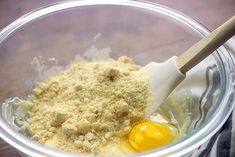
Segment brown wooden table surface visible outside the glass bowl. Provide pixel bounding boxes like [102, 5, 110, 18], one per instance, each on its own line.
[0, 0, 235, 157]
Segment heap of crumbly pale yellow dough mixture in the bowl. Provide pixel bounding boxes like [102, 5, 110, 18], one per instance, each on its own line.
[28, 56, 150, 154]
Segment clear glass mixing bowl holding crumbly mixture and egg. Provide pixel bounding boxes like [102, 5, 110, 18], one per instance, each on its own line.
[0, 0, 234, 157]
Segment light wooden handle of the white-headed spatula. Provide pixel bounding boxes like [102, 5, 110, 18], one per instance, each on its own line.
[176, 15, 235, 73]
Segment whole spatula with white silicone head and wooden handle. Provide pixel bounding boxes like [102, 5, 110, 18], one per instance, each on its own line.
[145, 16, 235, 115]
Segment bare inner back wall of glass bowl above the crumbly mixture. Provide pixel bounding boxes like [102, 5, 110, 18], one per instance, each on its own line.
[0, 6, 204, 99]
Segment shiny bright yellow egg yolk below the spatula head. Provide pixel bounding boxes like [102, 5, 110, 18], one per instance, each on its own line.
[128, 121, 174, 152]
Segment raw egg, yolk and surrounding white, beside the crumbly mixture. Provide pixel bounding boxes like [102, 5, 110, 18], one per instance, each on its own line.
[98, 114, 179, 157]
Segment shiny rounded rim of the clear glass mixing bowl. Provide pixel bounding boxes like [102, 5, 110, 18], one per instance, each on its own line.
[0, 0, 234, 157]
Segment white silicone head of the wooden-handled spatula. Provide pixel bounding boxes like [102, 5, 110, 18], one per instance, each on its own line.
[145, 56, 185, 116]
